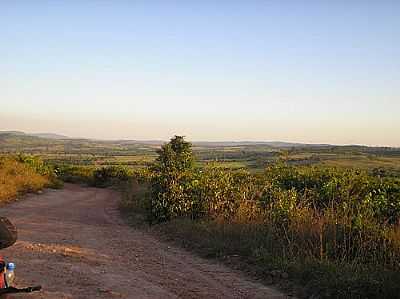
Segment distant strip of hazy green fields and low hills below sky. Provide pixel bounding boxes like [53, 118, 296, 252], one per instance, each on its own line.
[0, 131, 400, 176]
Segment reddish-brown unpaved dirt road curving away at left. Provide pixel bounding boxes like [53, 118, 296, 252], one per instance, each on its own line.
[0, 184, 286, 299]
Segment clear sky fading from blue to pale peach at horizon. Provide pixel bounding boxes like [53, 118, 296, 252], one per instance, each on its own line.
[0, 0, 400, 146]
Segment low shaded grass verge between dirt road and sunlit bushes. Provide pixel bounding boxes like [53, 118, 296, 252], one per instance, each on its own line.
[121, 181, 400, 298]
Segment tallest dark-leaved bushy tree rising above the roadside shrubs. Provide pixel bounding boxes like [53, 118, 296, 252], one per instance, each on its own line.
[149, 136, 194, 222]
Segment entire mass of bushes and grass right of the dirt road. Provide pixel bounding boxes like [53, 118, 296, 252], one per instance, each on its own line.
[124, 136, 400, 298]
